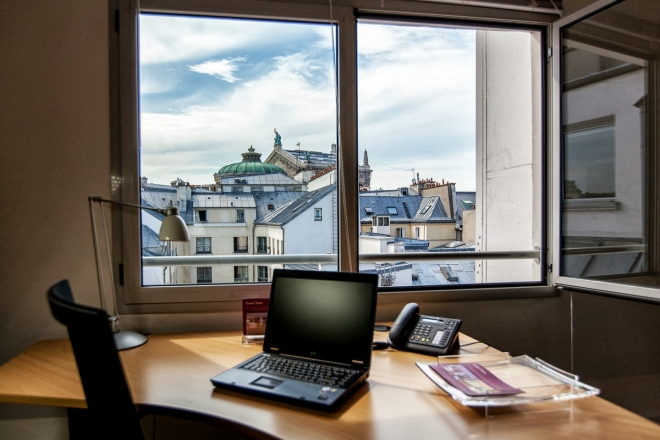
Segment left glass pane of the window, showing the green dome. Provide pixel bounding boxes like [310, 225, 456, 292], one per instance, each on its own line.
[139, 13, 338, 286]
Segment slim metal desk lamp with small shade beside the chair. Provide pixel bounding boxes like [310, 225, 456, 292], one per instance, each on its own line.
[89, 197, 190, 350]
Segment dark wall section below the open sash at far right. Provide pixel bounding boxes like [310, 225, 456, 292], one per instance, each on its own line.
[564, 291, 660, 422]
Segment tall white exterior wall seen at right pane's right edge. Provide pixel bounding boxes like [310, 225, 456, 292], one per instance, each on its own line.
[475, 31, 542, 283]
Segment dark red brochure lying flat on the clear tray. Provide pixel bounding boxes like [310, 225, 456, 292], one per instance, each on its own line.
[430, 363, 524, 396]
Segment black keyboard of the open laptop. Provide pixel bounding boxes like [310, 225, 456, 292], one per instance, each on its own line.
[241, 356, 358, 388]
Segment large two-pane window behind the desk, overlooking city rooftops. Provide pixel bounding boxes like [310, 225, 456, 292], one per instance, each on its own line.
[117, 0, 552, 311]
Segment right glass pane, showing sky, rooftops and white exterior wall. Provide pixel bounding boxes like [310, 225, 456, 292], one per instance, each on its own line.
[358, 20, 544, 288]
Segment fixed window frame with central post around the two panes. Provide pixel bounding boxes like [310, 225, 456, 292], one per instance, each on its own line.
[109, 0, 554, 313]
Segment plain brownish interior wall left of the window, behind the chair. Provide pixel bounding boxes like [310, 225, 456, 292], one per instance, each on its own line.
[0, 0, 110, 438]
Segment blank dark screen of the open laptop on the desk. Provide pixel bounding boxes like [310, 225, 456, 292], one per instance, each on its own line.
[264, 270, 378, 367]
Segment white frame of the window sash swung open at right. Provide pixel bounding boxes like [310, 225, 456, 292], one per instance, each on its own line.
[550, 0, 660, 300]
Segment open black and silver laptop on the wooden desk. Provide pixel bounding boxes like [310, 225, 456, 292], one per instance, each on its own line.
[211, 269, 378, 411]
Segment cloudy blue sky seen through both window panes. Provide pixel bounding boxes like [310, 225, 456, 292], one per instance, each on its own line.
[140, 14, 475, 191]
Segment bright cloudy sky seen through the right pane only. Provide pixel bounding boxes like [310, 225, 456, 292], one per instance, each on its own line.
[358, 24, 476, 190]
